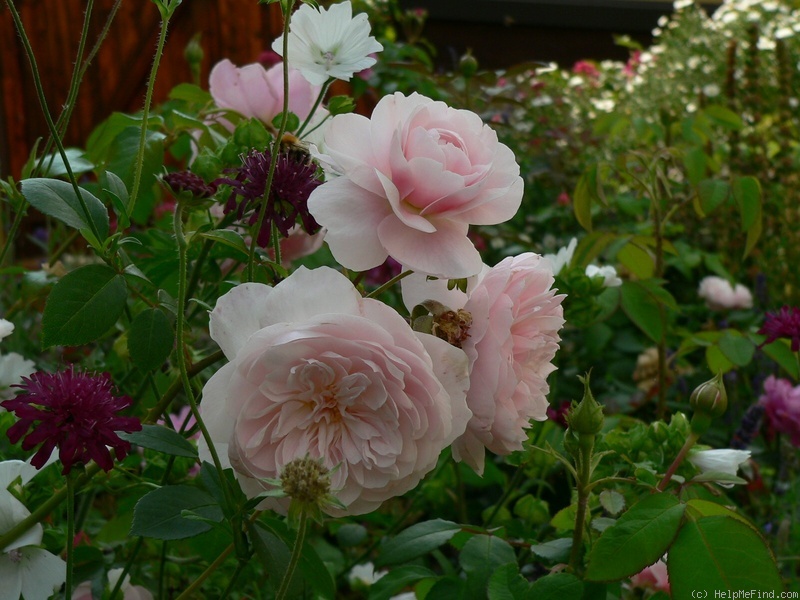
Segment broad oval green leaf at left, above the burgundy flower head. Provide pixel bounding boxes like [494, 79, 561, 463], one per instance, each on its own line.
[42, 265, 128, 348]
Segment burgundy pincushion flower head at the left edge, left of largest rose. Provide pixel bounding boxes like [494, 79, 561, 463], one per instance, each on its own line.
[0, 367, 142, 474]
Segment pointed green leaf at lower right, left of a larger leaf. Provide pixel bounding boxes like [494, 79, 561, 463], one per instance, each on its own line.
[586, 493, 686, 581]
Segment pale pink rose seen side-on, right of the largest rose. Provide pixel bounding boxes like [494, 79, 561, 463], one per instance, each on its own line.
[403, 253, 564, 473]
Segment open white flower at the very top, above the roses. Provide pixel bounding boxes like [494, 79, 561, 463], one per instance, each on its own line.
[272, 0, 383, 85]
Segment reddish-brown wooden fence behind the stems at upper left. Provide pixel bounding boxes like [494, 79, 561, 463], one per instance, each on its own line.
[0, 0, 282, 178]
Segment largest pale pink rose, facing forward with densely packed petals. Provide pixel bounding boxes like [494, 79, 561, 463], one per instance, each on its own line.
[201, 267, 471, 516]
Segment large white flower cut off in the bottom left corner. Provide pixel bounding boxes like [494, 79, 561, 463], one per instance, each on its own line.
[0, 460, 67, 600]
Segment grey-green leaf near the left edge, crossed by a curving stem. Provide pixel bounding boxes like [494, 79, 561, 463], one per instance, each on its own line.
[20, 178, 108, 241]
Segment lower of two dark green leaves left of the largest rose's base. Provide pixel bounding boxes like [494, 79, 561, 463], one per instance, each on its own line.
[131, 485, 222, 540]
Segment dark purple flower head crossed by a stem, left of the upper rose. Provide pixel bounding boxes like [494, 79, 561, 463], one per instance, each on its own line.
[219, 150, 322, 248]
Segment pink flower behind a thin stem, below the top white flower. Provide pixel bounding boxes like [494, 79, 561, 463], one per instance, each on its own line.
[208, 58, 320, 124]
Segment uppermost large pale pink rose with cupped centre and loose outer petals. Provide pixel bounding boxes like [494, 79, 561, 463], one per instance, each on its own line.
[308, 92, 523, 278]
